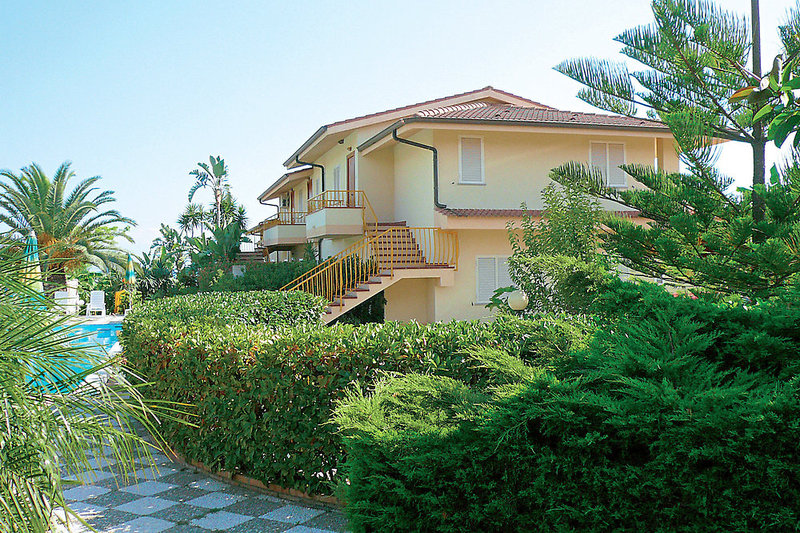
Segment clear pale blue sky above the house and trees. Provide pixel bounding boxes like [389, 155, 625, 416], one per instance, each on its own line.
[0, 0, 793, 251]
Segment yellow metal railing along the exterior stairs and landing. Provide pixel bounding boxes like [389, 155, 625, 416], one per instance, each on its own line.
[281, 226, 459, 307]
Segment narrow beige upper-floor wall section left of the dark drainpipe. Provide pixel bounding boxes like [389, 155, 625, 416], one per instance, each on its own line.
[392, 130, 434, 227]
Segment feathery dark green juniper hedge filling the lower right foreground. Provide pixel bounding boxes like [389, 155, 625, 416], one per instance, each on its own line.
[336, 284, 800, 532]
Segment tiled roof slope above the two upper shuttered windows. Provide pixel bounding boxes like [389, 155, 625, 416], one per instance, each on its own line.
[416, 102, 669, 130]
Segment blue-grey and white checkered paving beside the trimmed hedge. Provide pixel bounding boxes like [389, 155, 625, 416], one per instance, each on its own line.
[57, 448, 346, 533]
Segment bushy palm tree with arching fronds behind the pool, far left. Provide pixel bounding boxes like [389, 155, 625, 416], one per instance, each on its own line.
[0, 162, 136, 284]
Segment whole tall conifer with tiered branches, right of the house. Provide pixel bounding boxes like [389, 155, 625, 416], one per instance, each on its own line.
[551, 0, 800, 298]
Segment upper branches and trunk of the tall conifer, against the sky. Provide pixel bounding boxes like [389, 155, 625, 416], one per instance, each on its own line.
[556, 0, 780, 221]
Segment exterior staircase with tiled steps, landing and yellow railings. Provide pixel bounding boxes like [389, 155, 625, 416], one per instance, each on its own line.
[282, 222, 458, 324]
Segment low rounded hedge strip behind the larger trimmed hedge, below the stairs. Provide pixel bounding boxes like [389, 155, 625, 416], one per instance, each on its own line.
[122, 291, 325, 332]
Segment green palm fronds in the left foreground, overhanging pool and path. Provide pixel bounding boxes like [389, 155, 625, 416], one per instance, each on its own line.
[0, 243, 174, 533]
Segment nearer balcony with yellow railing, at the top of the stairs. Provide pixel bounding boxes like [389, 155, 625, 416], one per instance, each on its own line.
[306, 190, 377, 239]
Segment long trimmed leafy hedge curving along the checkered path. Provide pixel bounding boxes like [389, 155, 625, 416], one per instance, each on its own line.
[122, 318, 588, 493]
